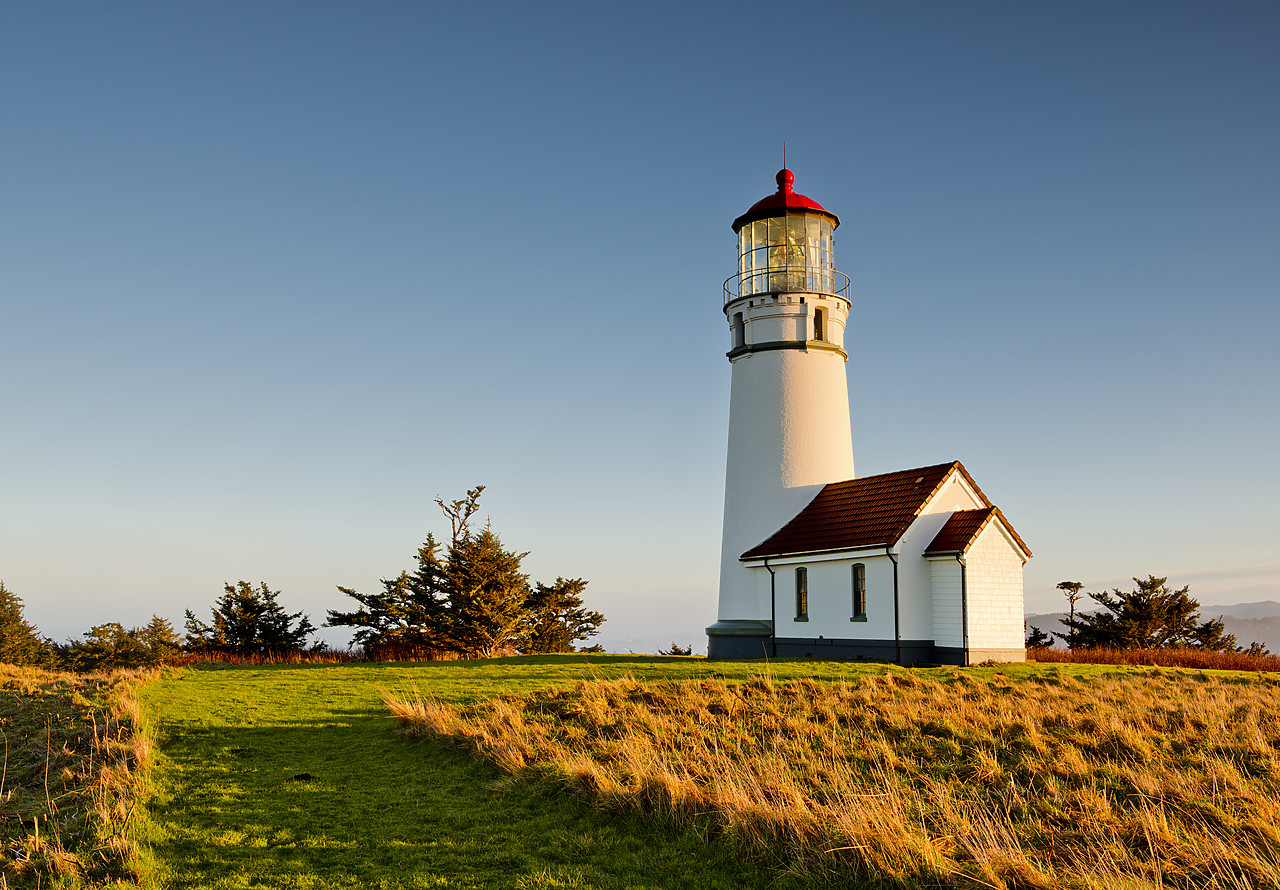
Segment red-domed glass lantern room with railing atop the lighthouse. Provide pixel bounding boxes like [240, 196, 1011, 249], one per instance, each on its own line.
[724, 169, 849, 306]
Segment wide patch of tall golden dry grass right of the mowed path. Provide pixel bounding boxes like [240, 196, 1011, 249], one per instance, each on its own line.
[387, 667, 1280, 890]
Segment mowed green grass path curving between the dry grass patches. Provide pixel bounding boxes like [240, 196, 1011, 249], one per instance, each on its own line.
[142, 656, 942, 889]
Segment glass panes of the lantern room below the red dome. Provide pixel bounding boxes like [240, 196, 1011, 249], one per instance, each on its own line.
[737, 214, 836, 297]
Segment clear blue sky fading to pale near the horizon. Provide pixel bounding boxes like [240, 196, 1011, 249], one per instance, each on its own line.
[0, 1, 1280, 651]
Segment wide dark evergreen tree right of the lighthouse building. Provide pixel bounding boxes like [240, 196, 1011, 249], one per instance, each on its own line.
[1057, 575, 1235, 651]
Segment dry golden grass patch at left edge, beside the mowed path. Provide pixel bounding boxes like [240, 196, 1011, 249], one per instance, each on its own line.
[0, 663, 155, 887]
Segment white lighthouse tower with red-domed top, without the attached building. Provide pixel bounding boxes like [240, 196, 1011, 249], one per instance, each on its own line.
[707, 169, 854, 658]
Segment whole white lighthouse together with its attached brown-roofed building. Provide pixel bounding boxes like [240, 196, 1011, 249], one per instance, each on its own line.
[707, 170, 1032, 665]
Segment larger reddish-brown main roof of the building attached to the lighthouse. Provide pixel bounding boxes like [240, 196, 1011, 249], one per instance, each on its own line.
[739, 461, 1030, 560]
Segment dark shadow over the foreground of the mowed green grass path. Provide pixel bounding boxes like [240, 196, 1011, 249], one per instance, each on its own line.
[151, 701, 801, 889]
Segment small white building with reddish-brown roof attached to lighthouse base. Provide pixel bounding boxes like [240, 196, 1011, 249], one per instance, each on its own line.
[708, 461, 1032, 665]
